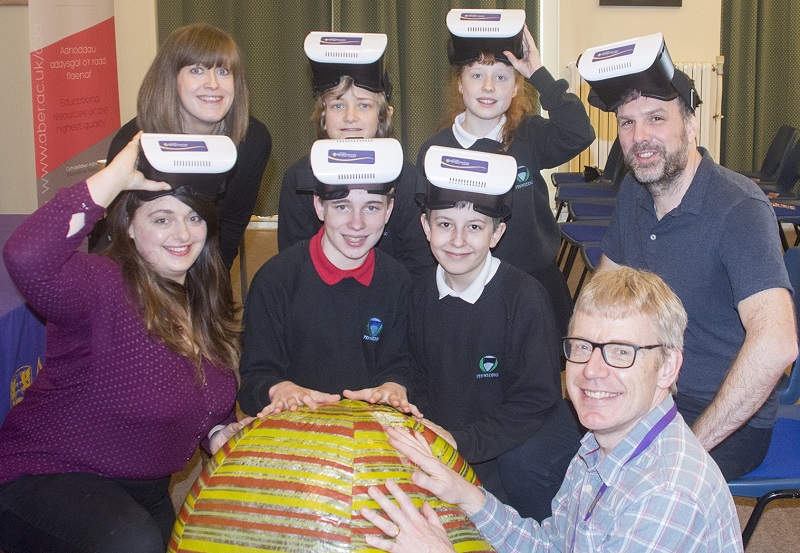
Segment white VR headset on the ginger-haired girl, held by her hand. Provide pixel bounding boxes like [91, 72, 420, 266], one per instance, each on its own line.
[447, 9, 525, 65]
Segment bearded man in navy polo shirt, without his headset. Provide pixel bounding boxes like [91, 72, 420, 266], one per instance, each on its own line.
[590, 69, 798, 480]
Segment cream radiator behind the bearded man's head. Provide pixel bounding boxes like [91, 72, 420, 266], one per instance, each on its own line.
[564, 56, 725, 171]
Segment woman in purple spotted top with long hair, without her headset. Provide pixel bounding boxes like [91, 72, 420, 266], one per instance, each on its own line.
[0, 136, 246, 553]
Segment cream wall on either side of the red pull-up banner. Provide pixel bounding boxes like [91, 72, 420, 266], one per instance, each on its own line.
[0, 0, 156, 213]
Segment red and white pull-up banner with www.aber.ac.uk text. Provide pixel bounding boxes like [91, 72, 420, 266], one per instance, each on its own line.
[28, 0, 120, 205]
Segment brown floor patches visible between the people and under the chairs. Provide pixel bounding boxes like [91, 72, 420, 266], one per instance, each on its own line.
[166, 219, 800, 553]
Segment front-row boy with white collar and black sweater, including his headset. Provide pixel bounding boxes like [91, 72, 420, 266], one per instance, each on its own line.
[410, 146, 581, 520]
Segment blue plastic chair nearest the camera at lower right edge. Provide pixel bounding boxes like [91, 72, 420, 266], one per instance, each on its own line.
[728, 247, 800, 547]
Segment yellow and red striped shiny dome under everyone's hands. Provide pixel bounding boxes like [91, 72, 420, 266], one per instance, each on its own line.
[168, 400, 494, 553]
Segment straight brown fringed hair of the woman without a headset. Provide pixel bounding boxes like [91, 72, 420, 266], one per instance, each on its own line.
[136, 23, 249, 146]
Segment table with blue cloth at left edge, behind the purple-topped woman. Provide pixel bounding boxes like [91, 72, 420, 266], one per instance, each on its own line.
[0, 215, 44, 422]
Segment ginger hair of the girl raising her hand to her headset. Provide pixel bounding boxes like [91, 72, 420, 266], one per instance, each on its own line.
[440, 52, 536, 152]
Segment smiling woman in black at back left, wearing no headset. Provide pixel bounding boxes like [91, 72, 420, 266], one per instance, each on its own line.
[90, 23, 272, 269]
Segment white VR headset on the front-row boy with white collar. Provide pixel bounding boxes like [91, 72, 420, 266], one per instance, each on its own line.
[416, 146, 517, 218]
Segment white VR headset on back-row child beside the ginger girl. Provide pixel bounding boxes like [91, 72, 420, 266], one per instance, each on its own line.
[303, 31, 392, 98]
